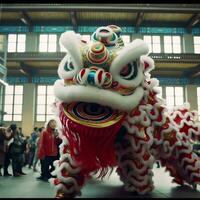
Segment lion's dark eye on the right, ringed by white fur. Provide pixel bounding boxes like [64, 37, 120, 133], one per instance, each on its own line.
[120, 61, 138, 80]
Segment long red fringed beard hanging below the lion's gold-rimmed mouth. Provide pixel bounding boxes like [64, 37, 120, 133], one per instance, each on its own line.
[60, 109, 123, 177]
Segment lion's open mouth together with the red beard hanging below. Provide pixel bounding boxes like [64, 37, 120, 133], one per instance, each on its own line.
[60, 102, 126, 173]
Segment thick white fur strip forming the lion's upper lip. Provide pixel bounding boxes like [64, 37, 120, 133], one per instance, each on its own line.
[54, 80, 144, 111]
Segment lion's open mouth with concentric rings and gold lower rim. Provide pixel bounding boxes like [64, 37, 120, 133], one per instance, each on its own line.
[63, 102, 126, 128]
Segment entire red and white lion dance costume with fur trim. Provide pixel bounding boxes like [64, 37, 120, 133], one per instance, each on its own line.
[50, 25, 200, 198]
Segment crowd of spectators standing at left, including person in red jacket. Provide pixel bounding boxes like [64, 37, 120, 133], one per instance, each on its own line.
[0, 119, 62, 181]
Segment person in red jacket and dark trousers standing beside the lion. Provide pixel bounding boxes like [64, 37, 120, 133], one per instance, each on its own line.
[38, 119, 60, 181]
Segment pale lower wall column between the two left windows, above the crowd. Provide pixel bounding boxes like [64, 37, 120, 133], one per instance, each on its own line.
[22, 83, 36, 135]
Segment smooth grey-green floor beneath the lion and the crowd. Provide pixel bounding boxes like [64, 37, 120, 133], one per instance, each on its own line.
[0, 166, 200, 198]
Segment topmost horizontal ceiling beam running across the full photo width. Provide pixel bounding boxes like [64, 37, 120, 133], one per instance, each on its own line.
[1, 3, 200, 13]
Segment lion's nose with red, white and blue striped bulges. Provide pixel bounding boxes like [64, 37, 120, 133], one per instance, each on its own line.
[76, 66, 112, 88]
